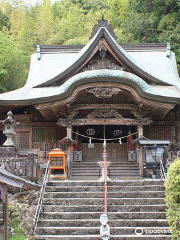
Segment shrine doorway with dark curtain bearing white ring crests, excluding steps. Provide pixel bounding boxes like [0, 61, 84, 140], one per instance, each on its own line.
[74, 125, 136, 162]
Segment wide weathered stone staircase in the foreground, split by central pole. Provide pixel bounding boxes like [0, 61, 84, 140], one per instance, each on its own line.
[35, 180, 171, 240]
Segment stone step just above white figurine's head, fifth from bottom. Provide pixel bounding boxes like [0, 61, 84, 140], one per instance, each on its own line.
[42, 204, 166, 212]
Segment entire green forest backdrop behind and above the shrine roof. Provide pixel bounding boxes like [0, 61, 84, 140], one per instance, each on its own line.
[0, 0, 180, 92]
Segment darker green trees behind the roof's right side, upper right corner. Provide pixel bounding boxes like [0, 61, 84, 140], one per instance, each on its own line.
[122, 0, 180, 69]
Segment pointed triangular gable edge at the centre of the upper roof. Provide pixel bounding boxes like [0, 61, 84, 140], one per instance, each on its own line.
[31, 27, 173, 87]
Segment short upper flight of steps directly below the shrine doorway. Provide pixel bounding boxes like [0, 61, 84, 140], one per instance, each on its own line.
[72, 161, 139, 180]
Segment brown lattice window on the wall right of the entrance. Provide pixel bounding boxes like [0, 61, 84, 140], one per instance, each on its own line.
[144, 126, 176, 142]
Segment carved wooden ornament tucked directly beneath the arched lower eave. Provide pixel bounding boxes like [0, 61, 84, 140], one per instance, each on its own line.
[86, 87, 121, 98]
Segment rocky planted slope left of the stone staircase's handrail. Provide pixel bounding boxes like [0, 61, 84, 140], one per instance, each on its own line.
[8, 189, 38, 240]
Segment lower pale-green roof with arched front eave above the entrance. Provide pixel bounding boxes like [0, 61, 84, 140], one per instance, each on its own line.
[0, 69, 180, 104]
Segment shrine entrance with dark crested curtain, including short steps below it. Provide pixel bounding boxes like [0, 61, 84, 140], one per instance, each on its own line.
[72, 125, 139, 180]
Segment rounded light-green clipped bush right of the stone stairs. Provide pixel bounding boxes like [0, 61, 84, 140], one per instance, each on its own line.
[165, 159, 180, 240]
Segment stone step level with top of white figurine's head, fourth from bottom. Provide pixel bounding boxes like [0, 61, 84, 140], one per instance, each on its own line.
[41, 211, 166, 219]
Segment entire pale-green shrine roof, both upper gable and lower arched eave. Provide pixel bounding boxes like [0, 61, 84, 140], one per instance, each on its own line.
[0, 24, 180, 104]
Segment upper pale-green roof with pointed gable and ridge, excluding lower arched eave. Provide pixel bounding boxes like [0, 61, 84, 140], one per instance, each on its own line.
[23, 28, 180, 87]
